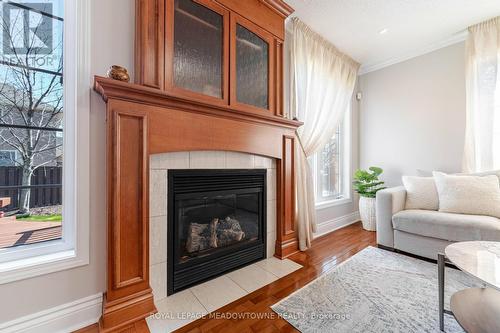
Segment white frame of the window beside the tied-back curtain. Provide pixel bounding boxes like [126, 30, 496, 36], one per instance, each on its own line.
[311, 105, 352, 210]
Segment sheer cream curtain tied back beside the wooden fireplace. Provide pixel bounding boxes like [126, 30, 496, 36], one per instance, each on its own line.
[290, 18, 359, 250]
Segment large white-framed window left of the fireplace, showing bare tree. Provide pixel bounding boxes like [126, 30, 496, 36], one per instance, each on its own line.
[0, 0, 89, 283]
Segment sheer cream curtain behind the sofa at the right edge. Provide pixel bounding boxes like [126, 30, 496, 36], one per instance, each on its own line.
[463, 17, 500, 172]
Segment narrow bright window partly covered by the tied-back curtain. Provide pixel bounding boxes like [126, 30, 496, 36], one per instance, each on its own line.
[309, 112, 350, 207]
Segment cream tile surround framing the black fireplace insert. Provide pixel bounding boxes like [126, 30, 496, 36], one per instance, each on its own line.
[149, 151, 282, 302]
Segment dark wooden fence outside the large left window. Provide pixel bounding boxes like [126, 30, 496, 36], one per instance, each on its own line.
[0, 166, 62, 212]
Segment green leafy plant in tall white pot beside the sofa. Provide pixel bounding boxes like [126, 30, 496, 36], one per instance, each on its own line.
[353, 167, 385, 231]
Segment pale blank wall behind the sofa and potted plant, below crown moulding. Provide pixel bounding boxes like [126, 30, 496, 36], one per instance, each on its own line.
[359, 42, 465, 185]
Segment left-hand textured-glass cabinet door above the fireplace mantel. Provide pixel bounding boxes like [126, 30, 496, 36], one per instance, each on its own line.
[167, 0, 228, 101]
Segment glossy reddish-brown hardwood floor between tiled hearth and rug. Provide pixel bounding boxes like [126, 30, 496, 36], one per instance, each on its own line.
[76, 222, 376, 333]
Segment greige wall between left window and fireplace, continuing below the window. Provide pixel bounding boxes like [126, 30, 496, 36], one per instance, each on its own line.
[0, 0, 134, 323]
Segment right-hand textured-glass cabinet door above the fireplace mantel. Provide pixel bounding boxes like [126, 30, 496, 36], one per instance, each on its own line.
[231, 17, 273, 110]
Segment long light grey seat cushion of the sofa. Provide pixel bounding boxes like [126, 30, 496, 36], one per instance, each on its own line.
[392, 210, 500, 242]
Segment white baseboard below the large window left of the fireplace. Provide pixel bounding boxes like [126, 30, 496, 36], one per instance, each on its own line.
[0, 294, 102, 333]
